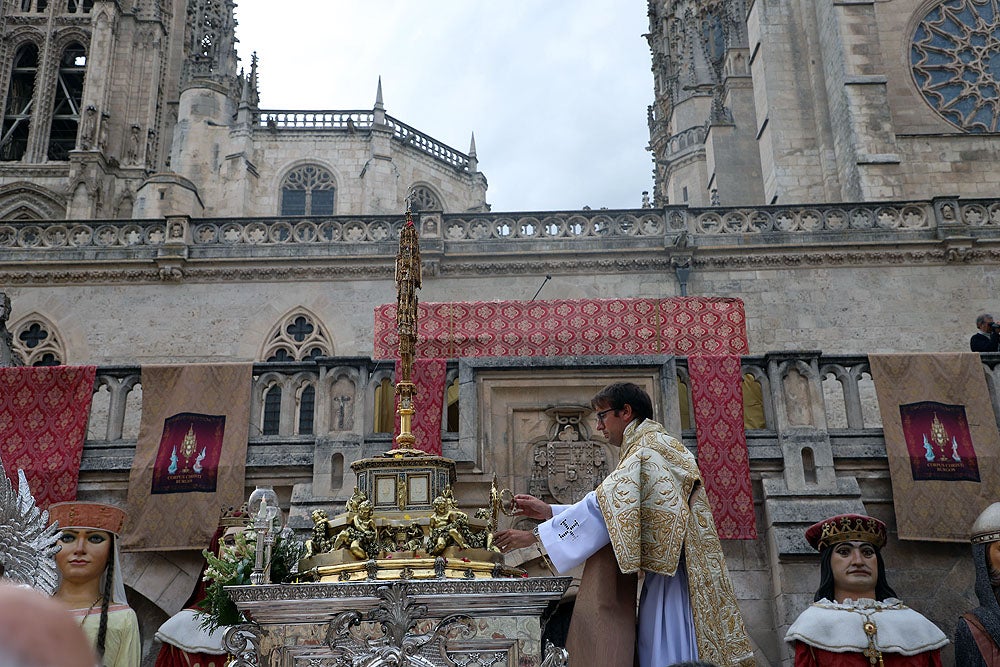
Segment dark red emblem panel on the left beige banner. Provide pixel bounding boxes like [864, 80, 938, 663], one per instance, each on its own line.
[150, 412, 226, 494]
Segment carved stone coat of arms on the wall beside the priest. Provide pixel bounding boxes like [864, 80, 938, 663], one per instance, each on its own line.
[528, 406, 608, 505]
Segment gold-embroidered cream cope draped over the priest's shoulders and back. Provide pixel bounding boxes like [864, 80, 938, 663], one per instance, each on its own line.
[597, 419, 754, 667]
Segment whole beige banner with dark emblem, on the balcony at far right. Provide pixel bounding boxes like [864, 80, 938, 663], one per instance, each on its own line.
[869, 352, 1000, 543]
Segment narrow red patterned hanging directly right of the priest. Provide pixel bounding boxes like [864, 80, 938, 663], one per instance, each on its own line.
[688, 354, 757, 540]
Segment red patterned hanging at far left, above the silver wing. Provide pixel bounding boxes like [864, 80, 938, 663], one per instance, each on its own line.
[0, 366, 97, 508]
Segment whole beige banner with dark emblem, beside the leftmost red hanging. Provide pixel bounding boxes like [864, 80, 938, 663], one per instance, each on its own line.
[122, 364, 253, 551]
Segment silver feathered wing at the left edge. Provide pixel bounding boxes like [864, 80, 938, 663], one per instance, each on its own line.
[0, 463, 59, 595]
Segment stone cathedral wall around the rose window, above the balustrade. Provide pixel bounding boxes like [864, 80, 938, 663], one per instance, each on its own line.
[649, 0, 1000, 204]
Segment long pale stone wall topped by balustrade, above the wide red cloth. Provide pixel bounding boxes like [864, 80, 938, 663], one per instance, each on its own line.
[0, 200, 1000, 364]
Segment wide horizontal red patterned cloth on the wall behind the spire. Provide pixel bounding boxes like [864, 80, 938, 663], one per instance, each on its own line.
[374, 297, 748, 359]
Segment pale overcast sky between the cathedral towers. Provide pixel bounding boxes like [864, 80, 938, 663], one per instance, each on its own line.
[237, 0, 653, 211]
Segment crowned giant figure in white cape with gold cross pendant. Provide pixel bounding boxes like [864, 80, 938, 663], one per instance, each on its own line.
[785, 514, 948, 667]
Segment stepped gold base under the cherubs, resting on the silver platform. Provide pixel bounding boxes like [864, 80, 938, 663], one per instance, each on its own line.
[299, 547, 527, 583]
